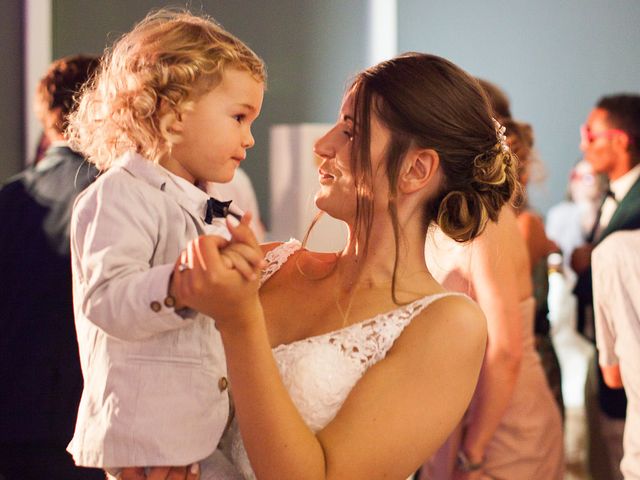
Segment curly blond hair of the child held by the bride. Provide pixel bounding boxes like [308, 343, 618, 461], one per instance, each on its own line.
[67, 9, 266, 170]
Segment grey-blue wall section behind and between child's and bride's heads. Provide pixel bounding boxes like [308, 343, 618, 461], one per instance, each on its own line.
[53, 0, 367, 227]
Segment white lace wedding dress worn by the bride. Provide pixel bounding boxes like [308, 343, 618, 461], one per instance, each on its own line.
[230, 240, 459, 479]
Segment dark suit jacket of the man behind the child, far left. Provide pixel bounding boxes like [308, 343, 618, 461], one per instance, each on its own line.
[0, 147, 97, 445]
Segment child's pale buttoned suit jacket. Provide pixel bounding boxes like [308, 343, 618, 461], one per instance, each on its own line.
[69, 153, 229, 468]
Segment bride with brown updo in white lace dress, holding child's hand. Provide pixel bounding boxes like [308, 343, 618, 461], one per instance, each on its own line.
[123, 53, 516, 480]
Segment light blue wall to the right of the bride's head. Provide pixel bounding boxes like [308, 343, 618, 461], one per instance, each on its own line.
[398, 0, 640, 212]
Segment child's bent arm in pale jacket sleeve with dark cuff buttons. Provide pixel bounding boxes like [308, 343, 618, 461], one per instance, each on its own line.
[71, 184, 195, 340]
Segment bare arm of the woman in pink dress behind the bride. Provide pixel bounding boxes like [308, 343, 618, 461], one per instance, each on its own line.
[462, 209, 529, 463]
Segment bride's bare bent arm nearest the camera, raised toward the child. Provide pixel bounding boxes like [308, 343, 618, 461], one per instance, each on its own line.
[178, 231, 486, 480]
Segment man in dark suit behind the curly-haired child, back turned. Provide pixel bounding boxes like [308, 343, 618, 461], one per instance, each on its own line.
[0, 56, 104, 480]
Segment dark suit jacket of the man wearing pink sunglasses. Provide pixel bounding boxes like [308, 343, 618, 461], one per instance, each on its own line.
[574, 172, 640, 418]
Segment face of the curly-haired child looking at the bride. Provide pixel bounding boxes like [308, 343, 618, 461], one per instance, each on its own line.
[166, 68, 264, 183]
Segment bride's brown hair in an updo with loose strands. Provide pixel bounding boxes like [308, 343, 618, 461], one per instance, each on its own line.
[351, 53, 517, 248]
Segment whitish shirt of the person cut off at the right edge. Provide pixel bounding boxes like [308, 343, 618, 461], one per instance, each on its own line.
[592, 230, 640, 479]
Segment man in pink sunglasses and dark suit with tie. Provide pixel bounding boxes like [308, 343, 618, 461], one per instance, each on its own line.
[571, 95, 640, 480]
